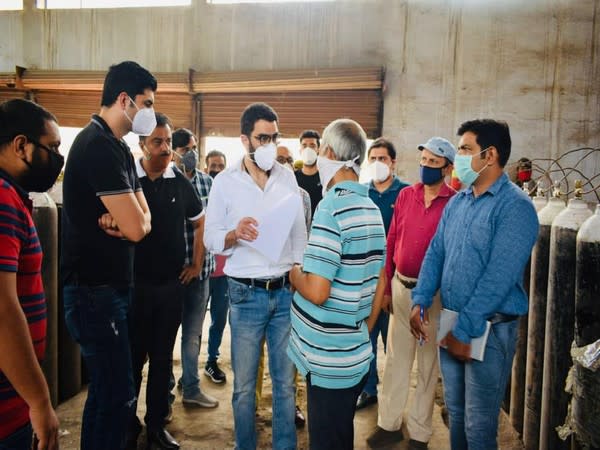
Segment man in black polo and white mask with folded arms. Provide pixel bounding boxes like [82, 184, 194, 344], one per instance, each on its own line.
[61, 61, 157, 450]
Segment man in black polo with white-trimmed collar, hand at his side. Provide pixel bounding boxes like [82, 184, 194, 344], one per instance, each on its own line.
[128, 113, 204, 449]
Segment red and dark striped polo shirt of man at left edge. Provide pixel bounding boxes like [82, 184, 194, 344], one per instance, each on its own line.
[0, 171, 46, 439]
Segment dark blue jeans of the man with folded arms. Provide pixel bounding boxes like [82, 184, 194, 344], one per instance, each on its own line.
[63, 285, 136, 450]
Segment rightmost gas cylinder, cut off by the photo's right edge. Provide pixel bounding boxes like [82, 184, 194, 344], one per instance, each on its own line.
[571, 205, 600, 448]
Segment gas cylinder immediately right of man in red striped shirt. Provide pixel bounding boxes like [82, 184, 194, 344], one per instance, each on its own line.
[30, 193, 58, 406]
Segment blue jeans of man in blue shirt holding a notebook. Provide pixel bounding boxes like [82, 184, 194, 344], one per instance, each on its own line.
[440, 320, 518, 450]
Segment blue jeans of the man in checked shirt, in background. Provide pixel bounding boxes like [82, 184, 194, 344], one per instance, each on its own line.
[181, 278, 208, 398]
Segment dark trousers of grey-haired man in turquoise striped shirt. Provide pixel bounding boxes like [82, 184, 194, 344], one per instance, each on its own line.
[306, 373, 369, 450]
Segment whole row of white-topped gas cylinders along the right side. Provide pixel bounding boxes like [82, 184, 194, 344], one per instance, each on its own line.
[510, 193, 600, 450]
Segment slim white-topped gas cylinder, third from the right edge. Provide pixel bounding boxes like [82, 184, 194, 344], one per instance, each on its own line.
[523, 197, 565, 450]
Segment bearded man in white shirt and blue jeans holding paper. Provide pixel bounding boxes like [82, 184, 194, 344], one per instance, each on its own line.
[204, 103, 306, 449]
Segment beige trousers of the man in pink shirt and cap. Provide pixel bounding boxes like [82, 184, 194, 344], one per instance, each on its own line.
[377, 273, 441, 442]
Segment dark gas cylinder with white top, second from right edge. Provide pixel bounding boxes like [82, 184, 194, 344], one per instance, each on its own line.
[540, 198, 592, 450]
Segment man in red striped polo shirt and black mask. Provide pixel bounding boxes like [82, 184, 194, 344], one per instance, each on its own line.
[0, 99, 64, 450]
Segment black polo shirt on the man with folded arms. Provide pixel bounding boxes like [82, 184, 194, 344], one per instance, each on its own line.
[61, 115, 142, 286]
